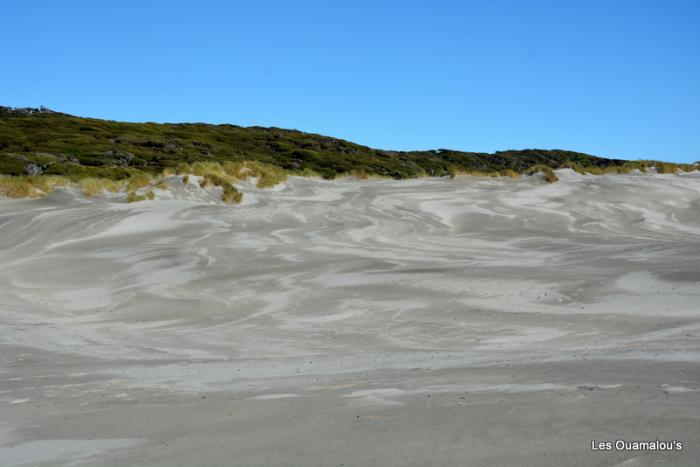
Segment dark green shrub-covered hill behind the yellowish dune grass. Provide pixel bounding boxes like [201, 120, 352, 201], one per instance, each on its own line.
[0, 107, 652, 179]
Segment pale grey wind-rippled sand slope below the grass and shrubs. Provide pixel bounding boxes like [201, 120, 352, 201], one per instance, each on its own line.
[0, 171, 700, 466]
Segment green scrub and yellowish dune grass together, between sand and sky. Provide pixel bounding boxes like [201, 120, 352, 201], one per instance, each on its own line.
[0, 107, 696, 202]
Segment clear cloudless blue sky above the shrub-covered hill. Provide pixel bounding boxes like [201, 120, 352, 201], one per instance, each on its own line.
[0, 0, 700, 161]
